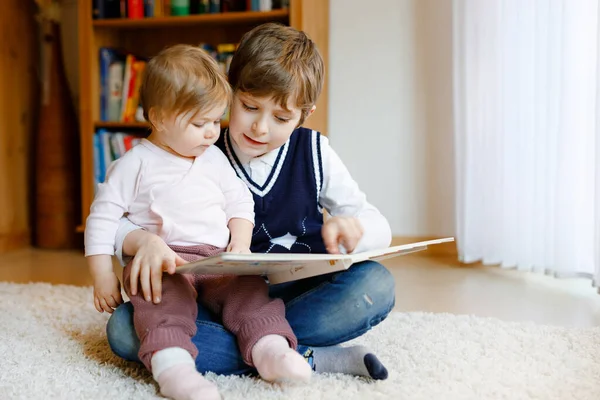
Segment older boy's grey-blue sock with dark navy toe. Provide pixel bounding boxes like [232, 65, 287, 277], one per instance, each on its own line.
[304, 346, 388, 380]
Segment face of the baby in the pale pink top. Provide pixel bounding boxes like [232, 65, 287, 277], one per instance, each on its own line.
[155, 105, 225, 158]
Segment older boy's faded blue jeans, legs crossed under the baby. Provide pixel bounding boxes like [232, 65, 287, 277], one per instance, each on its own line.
[106, 261, 395, 375]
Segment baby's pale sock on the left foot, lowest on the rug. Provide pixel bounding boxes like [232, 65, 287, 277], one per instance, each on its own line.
[151, 347, 221, 400]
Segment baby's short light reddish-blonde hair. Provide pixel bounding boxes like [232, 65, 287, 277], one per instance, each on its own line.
[140, 44, 231, 124]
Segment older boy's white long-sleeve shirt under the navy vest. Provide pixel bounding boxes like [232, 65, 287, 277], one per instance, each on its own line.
[116, 135, 392, 263]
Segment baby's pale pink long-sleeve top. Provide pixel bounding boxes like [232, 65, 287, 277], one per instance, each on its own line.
[85, 139, 254, 256]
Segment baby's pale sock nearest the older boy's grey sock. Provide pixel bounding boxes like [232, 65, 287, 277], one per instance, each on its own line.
[252, 335, 312, 382]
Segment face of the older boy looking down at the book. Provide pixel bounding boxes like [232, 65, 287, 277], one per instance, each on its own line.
[229, 91, 302, 157]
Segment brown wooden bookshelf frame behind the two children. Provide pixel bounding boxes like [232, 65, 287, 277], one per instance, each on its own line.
[77, 0, 329, 232]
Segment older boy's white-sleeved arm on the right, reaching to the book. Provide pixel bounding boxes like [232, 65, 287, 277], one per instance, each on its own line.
[319, 136, 392, 253]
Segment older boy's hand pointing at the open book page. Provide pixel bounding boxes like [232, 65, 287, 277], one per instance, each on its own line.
[321, 217, 364, 254]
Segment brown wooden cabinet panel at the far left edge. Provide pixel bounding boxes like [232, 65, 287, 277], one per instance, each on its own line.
[0, 0, 39, 253]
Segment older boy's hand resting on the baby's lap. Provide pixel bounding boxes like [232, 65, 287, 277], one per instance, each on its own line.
[129, 233, 187, 304]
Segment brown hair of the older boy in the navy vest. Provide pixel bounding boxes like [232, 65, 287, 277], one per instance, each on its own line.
[229, 23, 325, 125]
